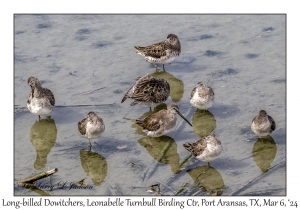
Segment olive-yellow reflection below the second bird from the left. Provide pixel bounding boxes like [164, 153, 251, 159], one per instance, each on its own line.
[80, 149, 107, 186]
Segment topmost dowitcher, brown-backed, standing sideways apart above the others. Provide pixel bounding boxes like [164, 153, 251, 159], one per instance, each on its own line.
[134, 34, 181, 71]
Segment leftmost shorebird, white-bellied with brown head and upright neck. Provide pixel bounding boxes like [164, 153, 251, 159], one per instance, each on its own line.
[27, 77, 55, 119]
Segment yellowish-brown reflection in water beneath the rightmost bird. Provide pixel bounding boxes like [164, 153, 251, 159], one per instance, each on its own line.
[252, 135, 277, 173]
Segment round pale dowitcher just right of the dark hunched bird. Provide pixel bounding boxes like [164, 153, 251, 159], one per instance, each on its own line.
[190, 82, 215, 109]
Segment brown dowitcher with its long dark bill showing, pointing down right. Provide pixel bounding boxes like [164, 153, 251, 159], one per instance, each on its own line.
[136, 103, 192, 137]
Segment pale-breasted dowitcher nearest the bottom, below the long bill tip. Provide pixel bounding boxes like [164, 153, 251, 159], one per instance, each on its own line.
[183, 134, 223, 165]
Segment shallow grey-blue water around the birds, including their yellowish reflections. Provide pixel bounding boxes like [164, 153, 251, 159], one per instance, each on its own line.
[14, 15, 286, 195]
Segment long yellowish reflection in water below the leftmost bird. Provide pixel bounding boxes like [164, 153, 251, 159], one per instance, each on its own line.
[29, 117, 57, 170]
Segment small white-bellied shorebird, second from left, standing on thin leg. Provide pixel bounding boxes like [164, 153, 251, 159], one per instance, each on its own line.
[78, 112, 105, 147]
